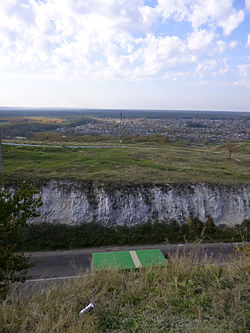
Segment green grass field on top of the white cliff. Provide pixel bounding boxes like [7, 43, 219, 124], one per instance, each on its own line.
[3, 143, 250, 184]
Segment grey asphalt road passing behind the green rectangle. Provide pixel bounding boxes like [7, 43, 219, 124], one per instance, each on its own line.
[27, 243, 239, 282]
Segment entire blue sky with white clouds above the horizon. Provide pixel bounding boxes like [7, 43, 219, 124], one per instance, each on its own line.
[0, 0, 250, 111]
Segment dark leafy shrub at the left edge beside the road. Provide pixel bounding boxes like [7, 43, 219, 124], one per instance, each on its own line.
[0, 182, 41, 292]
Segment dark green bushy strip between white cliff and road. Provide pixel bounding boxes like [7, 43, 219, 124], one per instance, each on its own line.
[17, 219, 250, 251]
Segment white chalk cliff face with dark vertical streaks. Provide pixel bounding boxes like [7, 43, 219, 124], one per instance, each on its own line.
[37, 180, 250, 226]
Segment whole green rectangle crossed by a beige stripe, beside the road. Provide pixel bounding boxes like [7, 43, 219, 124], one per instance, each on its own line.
[92, 249, 166, 271]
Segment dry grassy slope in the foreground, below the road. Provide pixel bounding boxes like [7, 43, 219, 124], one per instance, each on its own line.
[0, 248, 250, 333]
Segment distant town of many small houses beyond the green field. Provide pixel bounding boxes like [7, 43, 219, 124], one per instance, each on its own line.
[57, 117, 250, 143]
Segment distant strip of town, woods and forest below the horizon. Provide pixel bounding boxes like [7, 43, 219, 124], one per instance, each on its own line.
[0, 108, 250, 144]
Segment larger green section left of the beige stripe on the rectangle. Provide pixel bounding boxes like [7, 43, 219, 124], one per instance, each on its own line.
[92, 251, 135, 271]
